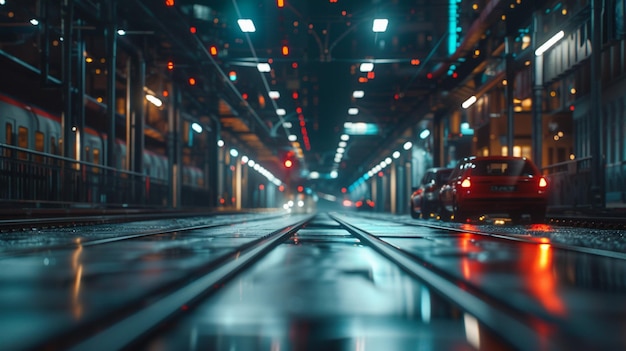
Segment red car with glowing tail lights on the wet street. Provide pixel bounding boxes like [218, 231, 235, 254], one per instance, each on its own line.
[439, 156, 548, 222]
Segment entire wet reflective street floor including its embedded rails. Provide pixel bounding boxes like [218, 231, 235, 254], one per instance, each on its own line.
[0, 213, 626, 350]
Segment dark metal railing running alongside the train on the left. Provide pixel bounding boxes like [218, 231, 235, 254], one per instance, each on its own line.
[0, 144, 169, 207]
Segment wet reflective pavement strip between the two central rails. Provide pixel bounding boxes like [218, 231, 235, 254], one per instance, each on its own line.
[139, 217, 508, 351]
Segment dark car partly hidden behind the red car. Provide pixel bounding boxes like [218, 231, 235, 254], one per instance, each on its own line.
[409, 167, 452, 218]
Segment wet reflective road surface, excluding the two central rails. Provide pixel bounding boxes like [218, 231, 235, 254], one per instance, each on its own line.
[0, 210, 626, 350]
